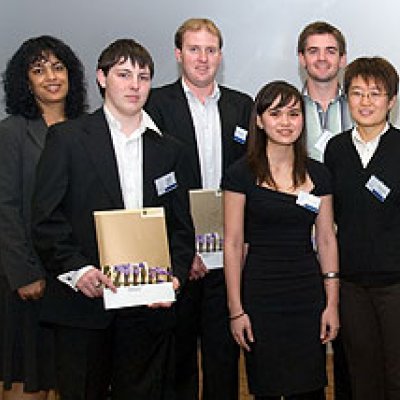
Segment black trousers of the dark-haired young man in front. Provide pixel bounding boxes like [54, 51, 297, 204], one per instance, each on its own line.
[56, 310, 175, 400]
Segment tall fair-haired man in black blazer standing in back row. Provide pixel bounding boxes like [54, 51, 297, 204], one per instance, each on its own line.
[146, 18, 253, 400]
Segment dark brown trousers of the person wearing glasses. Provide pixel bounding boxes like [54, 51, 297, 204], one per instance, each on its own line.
[340, 281, 400, 400]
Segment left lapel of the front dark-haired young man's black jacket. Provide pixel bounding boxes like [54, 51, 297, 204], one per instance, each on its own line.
[82, 109, 124, 208]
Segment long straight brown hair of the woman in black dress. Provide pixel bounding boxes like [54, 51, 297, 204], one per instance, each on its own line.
[247, 81, 307, 187]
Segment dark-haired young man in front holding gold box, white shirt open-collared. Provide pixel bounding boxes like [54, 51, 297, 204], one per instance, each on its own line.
[33, 39, 194, 400]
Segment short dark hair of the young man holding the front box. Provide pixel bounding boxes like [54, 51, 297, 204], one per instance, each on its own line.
[97, 39, 154, 97]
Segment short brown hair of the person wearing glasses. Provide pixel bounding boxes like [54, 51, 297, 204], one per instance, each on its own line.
[344, 57, 399, 99]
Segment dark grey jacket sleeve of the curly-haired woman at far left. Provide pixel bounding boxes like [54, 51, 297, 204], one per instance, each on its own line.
[0, 116, 47, 290]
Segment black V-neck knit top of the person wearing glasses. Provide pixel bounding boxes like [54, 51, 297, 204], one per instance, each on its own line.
[325, 127, 400, 284]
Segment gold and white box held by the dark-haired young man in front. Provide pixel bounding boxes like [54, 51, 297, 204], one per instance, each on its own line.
[94, 208, 175, 309]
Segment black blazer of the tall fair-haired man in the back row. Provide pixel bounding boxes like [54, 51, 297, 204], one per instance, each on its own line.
[145, 79, 253, 189]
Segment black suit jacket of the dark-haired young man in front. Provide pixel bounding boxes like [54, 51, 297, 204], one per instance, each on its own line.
[32, 109, 194, 328]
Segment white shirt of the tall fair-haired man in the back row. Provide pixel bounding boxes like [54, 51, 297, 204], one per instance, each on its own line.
[182, 79, 222, 189]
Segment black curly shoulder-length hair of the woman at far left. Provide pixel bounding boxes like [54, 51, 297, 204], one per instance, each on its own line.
[2, 35, 87, 119]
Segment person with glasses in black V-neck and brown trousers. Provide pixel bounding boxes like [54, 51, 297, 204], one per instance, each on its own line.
[325, 57, 400, 400]
